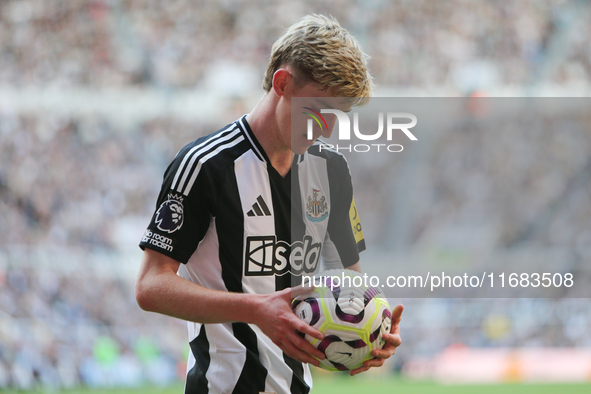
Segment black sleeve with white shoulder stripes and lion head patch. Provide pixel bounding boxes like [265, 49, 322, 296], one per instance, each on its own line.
[139, 144, 215, 264]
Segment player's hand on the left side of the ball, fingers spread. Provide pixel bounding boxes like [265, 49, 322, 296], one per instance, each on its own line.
[255, 286, 325, 366]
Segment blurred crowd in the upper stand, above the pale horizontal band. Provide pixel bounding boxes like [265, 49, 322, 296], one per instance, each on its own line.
[0, 0, 591, 94]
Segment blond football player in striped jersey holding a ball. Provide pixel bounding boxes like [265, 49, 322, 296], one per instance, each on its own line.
[136, 15, 402, 393]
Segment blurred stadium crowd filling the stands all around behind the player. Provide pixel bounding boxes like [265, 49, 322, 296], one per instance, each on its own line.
[0, 0, 591, 389]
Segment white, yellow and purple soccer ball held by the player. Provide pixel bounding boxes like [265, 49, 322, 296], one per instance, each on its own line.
[292, 269, 392, 371]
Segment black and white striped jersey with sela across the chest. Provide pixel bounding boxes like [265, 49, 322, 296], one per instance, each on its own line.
[140, 116, 365, 394]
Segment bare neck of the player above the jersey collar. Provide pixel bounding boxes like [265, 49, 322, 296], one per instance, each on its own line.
[246, 95, 294, 177]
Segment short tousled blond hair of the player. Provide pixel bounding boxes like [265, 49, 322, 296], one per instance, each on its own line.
[263, 15, 373, 105]
